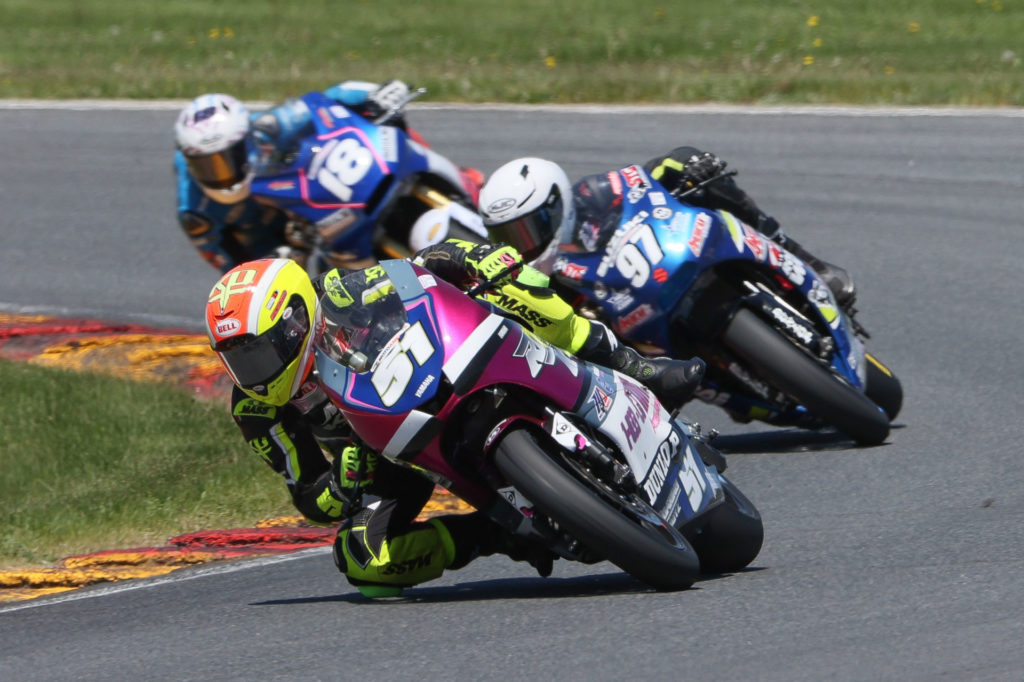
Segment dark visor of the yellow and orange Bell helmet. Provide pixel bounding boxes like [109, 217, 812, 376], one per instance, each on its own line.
[214, 296, 309, 388]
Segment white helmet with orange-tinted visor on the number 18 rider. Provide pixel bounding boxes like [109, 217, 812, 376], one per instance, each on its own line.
[174, 93, 254, 204]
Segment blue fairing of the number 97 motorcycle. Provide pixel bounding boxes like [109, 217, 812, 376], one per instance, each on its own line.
[552, 167, 864, 387]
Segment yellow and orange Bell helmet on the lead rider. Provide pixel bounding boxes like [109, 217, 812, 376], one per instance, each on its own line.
[206, 258, 316, 406]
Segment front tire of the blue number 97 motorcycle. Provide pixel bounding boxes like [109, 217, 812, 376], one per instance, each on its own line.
[722, 308, 889, 445]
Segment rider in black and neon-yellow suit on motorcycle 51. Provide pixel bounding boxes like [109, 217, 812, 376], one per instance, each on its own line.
[206, 248, 703, 597]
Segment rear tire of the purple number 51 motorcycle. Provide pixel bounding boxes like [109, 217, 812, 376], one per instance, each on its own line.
[683, 476, 765, 573]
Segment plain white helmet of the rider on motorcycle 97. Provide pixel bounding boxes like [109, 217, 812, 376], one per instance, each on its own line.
[479, 157, 575, 269]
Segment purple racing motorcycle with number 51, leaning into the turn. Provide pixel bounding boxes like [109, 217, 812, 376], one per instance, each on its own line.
[314, 260, 764, 590]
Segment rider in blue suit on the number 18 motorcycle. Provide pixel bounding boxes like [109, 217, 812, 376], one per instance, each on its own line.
[174, 80, 482, 272]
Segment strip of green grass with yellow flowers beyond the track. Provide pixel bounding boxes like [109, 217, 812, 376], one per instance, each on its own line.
[0, 0, 1024, 106]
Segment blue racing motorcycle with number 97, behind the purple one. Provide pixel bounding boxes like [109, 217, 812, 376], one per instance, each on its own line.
[551, 166, 903, 444]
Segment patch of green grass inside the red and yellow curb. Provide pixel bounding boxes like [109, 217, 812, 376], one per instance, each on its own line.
[0, 360, 295, 567]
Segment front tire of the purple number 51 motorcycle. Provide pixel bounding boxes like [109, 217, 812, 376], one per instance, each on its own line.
[495, 429, 700, 591]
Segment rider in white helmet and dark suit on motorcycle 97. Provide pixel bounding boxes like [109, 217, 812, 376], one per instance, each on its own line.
[480, 146, 856, 308]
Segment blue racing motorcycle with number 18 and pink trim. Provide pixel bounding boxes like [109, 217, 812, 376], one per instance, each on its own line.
[252, 88, 486, 275]
